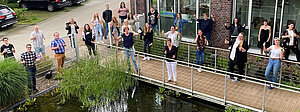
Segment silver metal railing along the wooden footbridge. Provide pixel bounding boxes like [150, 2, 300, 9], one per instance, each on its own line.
[97, 42, 300, 111]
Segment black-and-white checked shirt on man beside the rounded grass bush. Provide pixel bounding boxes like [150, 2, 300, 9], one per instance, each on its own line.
[21, 51, 37, 67]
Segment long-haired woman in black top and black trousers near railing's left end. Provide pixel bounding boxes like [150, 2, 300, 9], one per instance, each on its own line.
[82, 24, 96, 56]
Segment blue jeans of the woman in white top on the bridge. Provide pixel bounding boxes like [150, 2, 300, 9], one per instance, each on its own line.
[265, 59, 281, 83]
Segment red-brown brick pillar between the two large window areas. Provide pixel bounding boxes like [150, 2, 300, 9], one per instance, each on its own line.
[210, 0, 232, 48]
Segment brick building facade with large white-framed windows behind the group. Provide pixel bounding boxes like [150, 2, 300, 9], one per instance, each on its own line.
[131, 0, 300, 49]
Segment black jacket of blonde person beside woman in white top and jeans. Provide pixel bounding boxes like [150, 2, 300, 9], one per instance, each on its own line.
[228, 38, 249, 64]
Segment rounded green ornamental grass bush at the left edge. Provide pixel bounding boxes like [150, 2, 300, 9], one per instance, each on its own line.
[0, 60, 28, 105]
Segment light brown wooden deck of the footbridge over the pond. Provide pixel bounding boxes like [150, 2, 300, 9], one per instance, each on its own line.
[132, 57, 300, 112]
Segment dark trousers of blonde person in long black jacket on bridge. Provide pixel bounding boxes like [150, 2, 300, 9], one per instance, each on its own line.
[228, 59, 245, 79]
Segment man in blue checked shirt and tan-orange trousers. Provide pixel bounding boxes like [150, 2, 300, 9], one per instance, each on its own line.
[51, 32, 67, 72]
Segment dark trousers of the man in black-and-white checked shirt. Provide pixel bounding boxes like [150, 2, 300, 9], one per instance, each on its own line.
[27, 66, 37, 90]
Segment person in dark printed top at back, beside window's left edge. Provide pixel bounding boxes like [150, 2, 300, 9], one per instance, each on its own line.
[148, 7, 160, 31]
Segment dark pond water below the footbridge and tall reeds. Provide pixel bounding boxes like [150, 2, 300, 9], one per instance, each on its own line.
[14, 82, 224, 112]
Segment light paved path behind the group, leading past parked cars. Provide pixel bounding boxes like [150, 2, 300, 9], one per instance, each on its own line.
[1, 0, 129, 59]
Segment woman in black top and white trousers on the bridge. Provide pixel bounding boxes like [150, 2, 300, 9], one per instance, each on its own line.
[164, 38, 177, 85]
